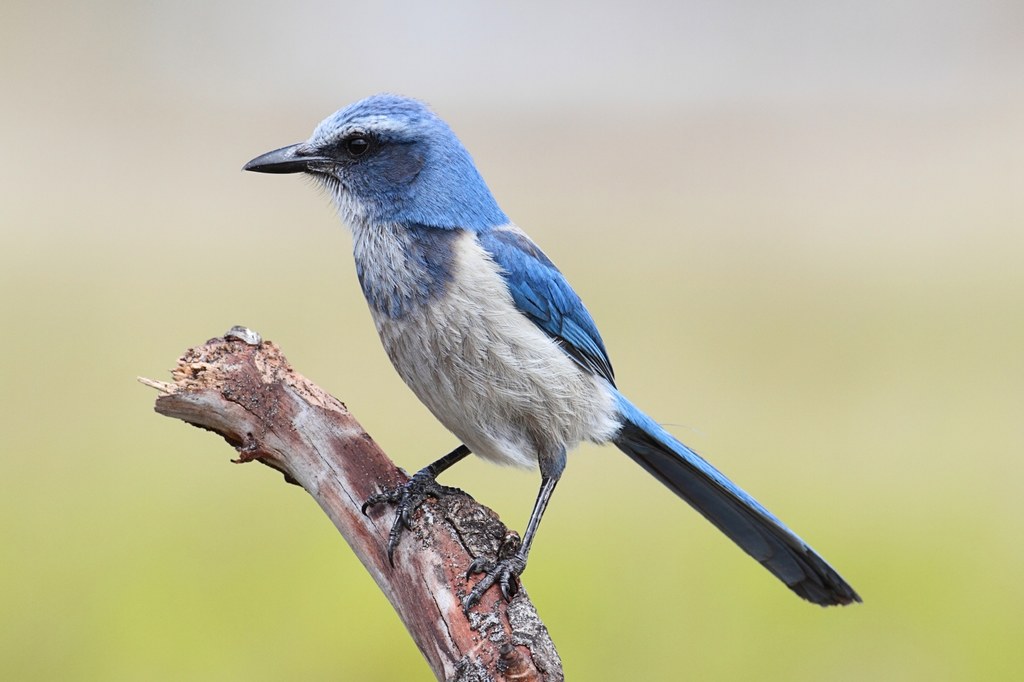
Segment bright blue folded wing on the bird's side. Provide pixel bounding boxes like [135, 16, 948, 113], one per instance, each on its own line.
[477, 227, 615, 378]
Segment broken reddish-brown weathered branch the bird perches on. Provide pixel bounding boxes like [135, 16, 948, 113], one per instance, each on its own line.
[140, 328, 563, 682]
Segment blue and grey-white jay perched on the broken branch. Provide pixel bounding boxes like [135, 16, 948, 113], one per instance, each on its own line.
[244, 93, 861, 609]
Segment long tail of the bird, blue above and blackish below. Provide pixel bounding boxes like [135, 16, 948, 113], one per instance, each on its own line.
[613, 393, 860, 606]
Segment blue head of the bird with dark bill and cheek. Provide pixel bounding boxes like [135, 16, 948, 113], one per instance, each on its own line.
[245, 94, 508, 229]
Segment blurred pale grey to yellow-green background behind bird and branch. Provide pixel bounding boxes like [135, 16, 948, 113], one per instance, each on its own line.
[0, 0, 1024, 680]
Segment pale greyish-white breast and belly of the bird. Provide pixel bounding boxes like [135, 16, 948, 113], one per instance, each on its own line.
[357, 225, 620, 466]
